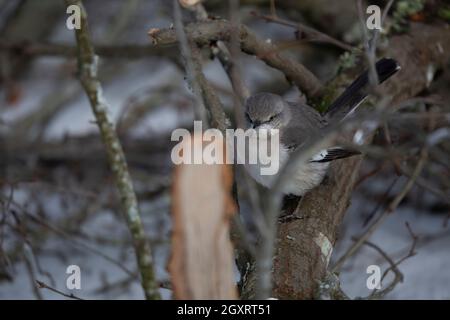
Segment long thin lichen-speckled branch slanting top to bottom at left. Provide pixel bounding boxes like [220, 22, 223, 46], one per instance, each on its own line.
[66, 0, 160, 299]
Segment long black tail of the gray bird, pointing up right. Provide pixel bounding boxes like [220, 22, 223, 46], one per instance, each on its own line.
[325, 58, 400, 120]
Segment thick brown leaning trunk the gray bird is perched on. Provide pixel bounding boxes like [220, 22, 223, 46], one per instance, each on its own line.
[273, 24, 450, 299]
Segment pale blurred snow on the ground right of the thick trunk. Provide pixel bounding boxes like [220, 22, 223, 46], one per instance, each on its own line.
[332, 193, 450, 299]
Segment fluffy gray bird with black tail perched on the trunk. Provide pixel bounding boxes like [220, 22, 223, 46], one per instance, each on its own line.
[245, 58, 400, 196]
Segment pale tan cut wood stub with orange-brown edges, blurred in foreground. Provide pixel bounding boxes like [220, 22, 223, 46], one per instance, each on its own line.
[169, 135, 237, 299]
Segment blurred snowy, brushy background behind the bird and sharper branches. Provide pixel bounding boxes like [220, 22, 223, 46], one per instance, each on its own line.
[0, 0, 450, 299]
